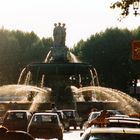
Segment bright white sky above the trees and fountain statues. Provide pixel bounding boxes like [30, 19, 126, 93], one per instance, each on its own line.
[0, 0, 140, 48]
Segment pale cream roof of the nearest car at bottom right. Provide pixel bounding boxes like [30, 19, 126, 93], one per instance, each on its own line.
[87, 127, 140, 134]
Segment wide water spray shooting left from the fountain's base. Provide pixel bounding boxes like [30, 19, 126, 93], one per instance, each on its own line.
[0, 85, 51, 112]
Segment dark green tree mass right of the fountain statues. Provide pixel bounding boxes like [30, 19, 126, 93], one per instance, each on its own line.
[73, 28, 140, 91]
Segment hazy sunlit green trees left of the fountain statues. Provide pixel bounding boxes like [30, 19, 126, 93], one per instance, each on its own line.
[0, 29, 53, 85]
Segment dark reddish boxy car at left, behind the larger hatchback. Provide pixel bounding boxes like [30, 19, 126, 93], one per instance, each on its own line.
[2, 110, 32, 131]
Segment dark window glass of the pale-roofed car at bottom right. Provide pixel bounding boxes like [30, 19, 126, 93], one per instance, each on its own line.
[86, 133, 140, 140]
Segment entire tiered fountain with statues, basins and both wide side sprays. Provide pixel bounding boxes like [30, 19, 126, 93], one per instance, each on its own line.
[0, 23, 140, 114]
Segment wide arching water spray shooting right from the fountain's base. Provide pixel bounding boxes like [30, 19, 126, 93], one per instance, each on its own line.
[75, 86, 140, 114]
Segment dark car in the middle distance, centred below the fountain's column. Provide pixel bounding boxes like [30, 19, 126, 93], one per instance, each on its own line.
[62, 109, 83, 129]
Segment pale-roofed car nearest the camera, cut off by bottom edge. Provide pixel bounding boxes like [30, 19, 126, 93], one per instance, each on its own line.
[80, 127, 140, 140]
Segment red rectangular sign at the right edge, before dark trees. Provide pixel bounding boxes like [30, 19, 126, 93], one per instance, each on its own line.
[132, 40, 140, 60]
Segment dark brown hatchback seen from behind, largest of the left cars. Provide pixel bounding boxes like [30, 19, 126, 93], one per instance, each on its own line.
[27, 112, 63, 140]
